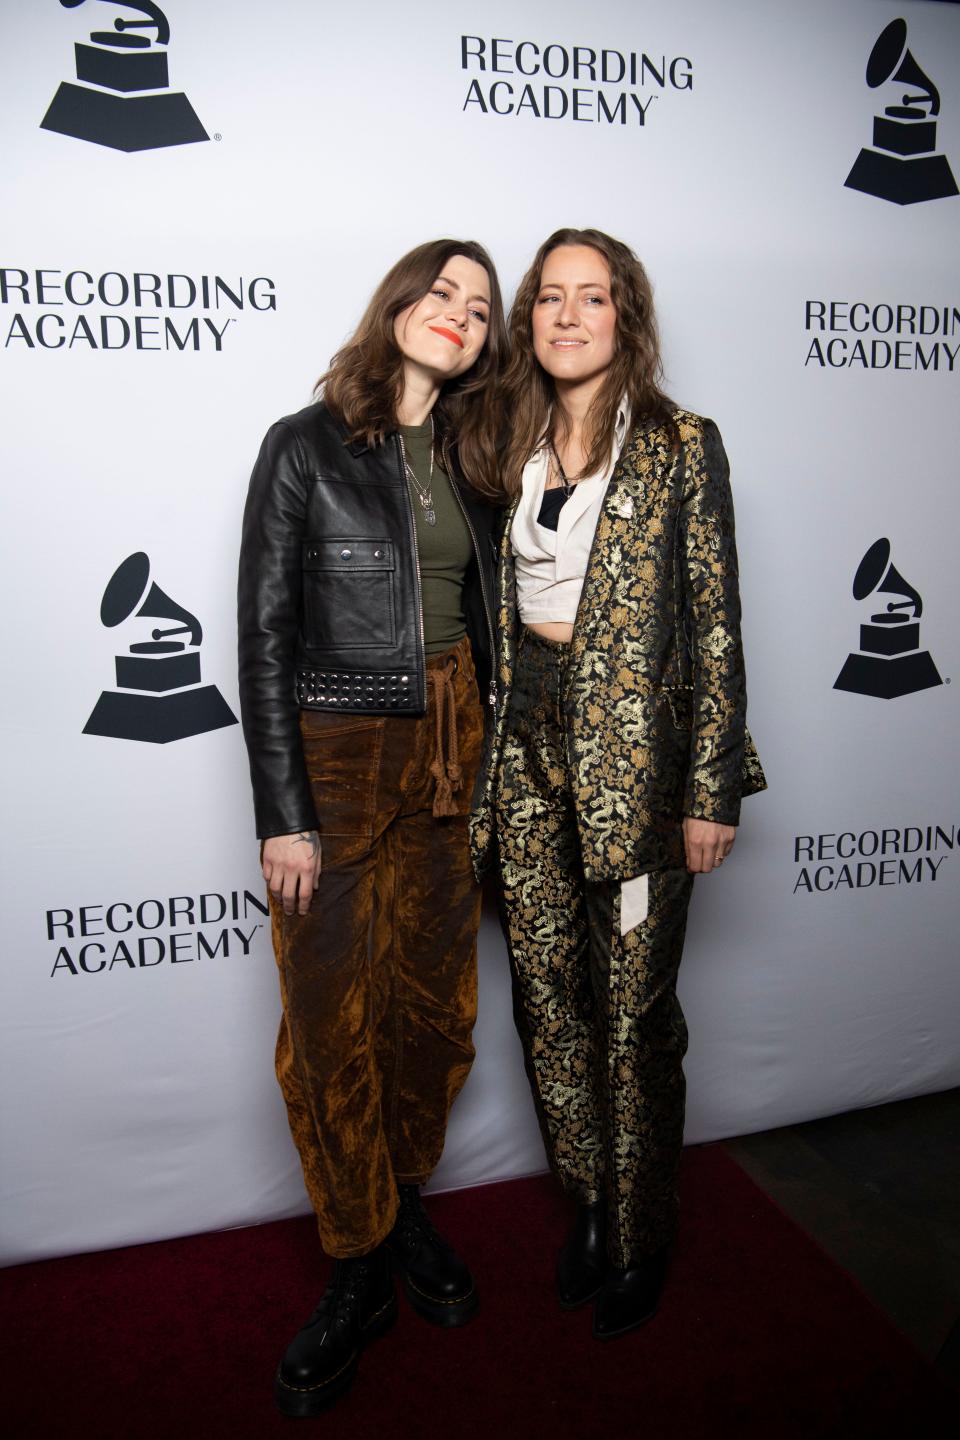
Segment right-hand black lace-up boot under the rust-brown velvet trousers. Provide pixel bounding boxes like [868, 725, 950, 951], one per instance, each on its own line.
[384, 1185, 479, 1325]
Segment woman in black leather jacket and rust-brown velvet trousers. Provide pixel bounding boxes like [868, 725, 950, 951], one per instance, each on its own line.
[239, 239, 505, 1416]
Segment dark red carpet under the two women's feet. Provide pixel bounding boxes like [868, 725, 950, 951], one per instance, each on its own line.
[0, 1146, 960, 1440]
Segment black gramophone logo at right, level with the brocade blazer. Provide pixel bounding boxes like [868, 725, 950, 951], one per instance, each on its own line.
[833, 539, 943, 700]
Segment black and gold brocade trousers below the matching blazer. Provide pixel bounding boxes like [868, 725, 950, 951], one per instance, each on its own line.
[497, 631, 692, 1267]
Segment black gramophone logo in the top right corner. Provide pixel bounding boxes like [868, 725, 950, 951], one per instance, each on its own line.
[843, 20, 957, 204]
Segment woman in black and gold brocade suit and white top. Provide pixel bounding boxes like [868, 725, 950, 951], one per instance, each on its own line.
[472, 230, 764, 1339]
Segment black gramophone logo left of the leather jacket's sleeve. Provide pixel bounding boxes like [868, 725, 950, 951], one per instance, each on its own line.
[83, 550, 236, 744]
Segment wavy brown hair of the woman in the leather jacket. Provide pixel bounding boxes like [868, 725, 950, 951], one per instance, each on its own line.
[317, 239, 507, 500]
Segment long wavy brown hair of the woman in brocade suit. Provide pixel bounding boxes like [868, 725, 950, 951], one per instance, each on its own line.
[501, 229, 674, 495]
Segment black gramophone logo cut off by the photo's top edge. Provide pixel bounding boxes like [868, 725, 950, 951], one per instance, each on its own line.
[40, 0, 210, 151]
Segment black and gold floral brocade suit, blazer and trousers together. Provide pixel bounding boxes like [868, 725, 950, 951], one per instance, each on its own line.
[471, 410, 766, 1266]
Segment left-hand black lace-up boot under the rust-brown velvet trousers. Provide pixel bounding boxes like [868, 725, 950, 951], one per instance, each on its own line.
[273, 1246, 397, 1417]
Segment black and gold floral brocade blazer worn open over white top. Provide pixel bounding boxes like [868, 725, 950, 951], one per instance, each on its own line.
[471, 410, 766, 881]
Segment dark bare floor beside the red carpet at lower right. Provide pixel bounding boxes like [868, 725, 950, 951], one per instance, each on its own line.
[725, 1090, 960, 1385]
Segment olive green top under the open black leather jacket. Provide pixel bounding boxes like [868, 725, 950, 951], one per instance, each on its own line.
[400, 420, 474, 655]
